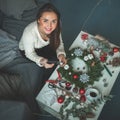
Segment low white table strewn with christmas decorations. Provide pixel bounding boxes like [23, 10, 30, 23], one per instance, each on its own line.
[36, 31, 120, 120]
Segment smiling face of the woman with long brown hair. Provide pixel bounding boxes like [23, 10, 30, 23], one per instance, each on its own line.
[38, 12, 58, 35]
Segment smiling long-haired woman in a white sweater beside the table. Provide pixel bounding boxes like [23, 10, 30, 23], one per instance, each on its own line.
[19, 3, 67, 68]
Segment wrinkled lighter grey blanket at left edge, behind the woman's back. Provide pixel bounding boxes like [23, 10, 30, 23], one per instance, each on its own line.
[0, 29, 21, 68]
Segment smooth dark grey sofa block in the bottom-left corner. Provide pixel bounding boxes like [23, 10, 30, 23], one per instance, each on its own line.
[0, 100, 33, 120]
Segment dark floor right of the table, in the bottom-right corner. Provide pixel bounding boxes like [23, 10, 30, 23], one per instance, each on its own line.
[98, 74, 120, 120]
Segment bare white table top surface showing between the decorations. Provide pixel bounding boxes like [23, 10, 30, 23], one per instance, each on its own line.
[36, 31, 120, 120]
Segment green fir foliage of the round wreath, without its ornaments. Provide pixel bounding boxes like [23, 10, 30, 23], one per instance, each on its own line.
[58, 48, 103, 88]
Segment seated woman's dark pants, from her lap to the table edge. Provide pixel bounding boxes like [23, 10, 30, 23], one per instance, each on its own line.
[3, 46, 57, 96]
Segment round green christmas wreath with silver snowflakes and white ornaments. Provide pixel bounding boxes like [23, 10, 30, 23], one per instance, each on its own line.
[58, 47, 104, 88]
